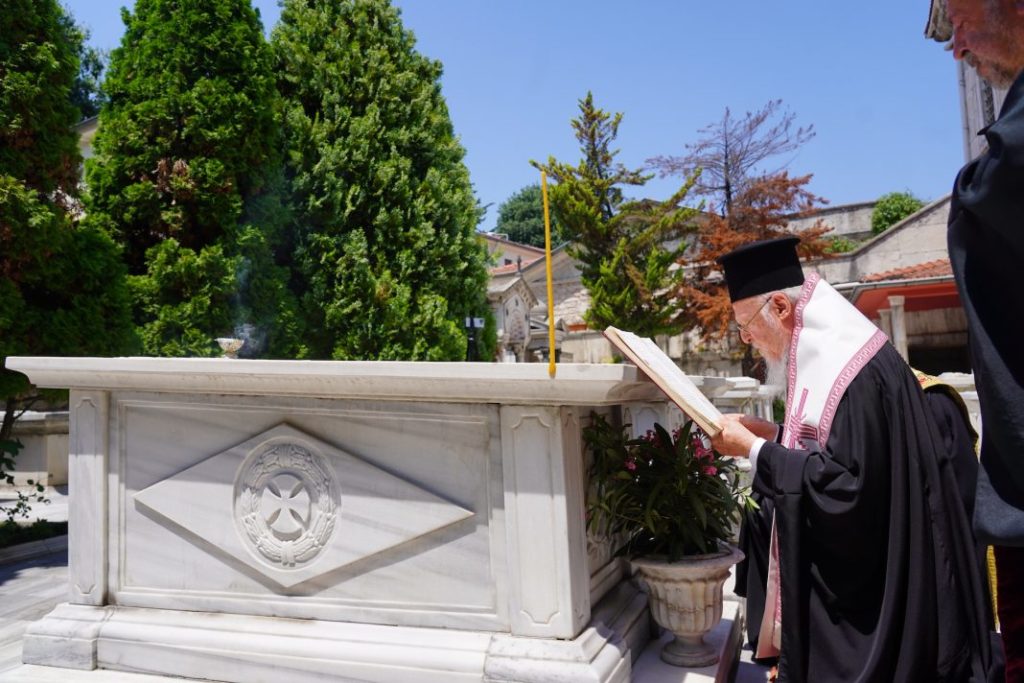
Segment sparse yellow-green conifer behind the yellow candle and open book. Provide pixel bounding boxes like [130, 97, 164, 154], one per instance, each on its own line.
[535, 92, 696, 336]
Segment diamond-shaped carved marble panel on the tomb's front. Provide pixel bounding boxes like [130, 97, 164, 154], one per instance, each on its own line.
[134, 424, 473, 588]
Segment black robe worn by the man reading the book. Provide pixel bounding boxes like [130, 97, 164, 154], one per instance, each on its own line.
[754, 344, 992, 683]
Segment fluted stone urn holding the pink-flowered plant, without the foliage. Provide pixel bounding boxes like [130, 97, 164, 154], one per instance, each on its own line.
[632, 546, 743, 667]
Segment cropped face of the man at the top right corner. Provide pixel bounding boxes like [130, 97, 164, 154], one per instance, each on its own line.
[946, 0, 1024, 88]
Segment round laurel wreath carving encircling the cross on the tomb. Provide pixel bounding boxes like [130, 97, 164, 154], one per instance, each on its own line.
[236, 442, 338, 568]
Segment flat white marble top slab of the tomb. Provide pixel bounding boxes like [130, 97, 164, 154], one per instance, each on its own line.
[5, 356, 662, 404]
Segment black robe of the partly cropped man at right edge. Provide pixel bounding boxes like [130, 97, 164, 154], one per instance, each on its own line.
[947, 69, 1024, 547]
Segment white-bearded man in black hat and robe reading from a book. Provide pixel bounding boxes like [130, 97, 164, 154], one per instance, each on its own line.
[713, 238, 999, 683]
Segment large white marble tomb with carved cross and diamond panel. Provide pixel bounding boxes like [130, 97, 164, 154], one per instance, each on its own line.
[7, 358, 761, 683]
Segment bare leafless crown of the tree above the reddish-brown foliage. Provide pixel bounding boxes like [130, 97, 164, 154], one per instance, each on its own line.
[647, 99, 815, 216]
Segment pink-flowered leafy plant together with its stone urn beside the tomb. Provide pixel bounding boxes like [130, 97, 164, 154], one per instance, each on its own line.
[584, 414, 755, 667]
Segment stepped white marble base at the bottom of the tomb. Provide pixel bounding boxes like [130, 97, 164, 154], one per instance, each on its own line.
[14, 582, 648, 683]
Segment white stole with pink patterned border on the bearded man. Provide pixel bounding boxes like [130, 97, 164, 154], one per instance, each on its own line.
[756, 273, 888, 657]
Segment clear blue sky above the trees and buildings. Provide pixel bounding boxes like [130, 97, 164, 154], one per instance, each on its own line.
[65, 0, 964, 229]
